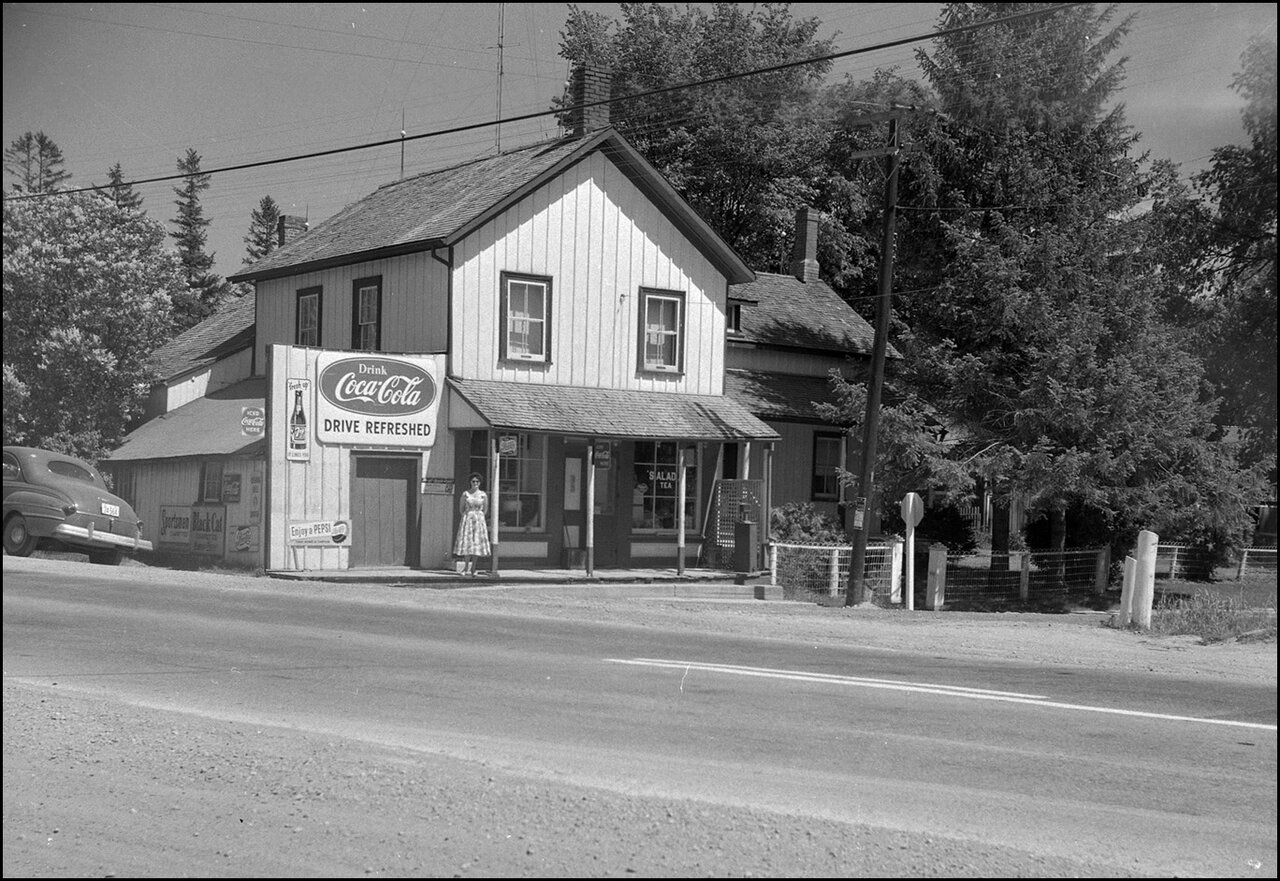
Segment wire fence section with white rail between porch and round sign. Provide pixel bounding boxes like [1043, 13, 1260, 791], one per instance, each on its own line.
[769, 542, 902, 599]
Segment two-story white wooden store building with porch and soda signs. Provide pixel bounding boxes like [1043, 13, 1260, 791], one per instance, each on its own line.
[105, 70, 890, 570]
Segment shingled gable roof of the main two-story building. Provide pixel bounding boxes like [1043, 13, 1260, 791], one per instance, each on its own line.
[230, 128, 754, 284]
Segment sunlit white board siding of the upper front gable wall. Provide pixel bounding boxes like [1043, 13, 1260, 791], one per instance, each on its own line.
[452, 152, 726, 394]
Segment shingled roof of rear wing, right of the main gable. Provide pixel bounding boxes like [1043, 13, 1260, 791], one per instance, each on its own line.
[728, 273, 901, 357]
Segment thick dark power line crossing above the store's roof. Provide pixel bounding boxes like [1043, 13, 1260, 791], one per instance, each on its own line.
[5, 3, 1088, 201]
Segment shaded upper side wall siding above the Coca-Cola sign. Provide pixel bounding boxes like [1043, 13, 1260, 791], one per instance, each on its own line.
[256, 252, 449, 373]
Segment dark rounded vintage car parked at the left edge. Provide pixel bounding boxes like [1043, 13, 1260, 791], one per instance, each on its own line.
[4, 447, 151, 566]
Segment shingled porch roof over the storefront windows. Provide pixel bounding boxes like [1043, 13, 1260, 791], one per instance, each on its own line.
[449, 378, 778, 443]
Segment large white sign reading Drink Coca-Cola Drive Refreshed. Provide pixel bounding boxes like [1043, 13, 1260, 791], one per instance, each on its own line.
[315, 352, 444, 448]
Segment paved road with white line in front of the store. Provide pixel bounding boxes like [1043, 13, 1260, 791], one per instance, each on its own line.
[4, 560, 1276, 876]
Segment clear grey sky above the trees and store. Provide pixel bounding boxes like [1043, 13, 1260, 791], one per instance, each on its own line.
[3, 3, 1276, 275]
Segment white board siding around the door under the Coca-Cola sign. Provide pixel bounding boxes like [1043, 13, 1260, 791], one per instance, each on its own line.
[264, 340, 457, 570]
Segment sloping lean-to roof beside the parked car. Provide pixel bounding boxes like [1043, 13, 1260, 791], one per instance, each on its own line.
[106, 378, 266, 462]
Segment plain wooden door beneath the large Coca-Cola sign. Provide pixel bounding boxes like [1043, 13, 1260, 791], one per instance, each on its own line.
[349, 456, 419, 569]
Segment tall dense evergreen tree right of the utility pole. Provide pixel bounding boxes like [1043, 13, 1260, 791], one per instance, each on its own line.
[900, 3, 1256, 558]
